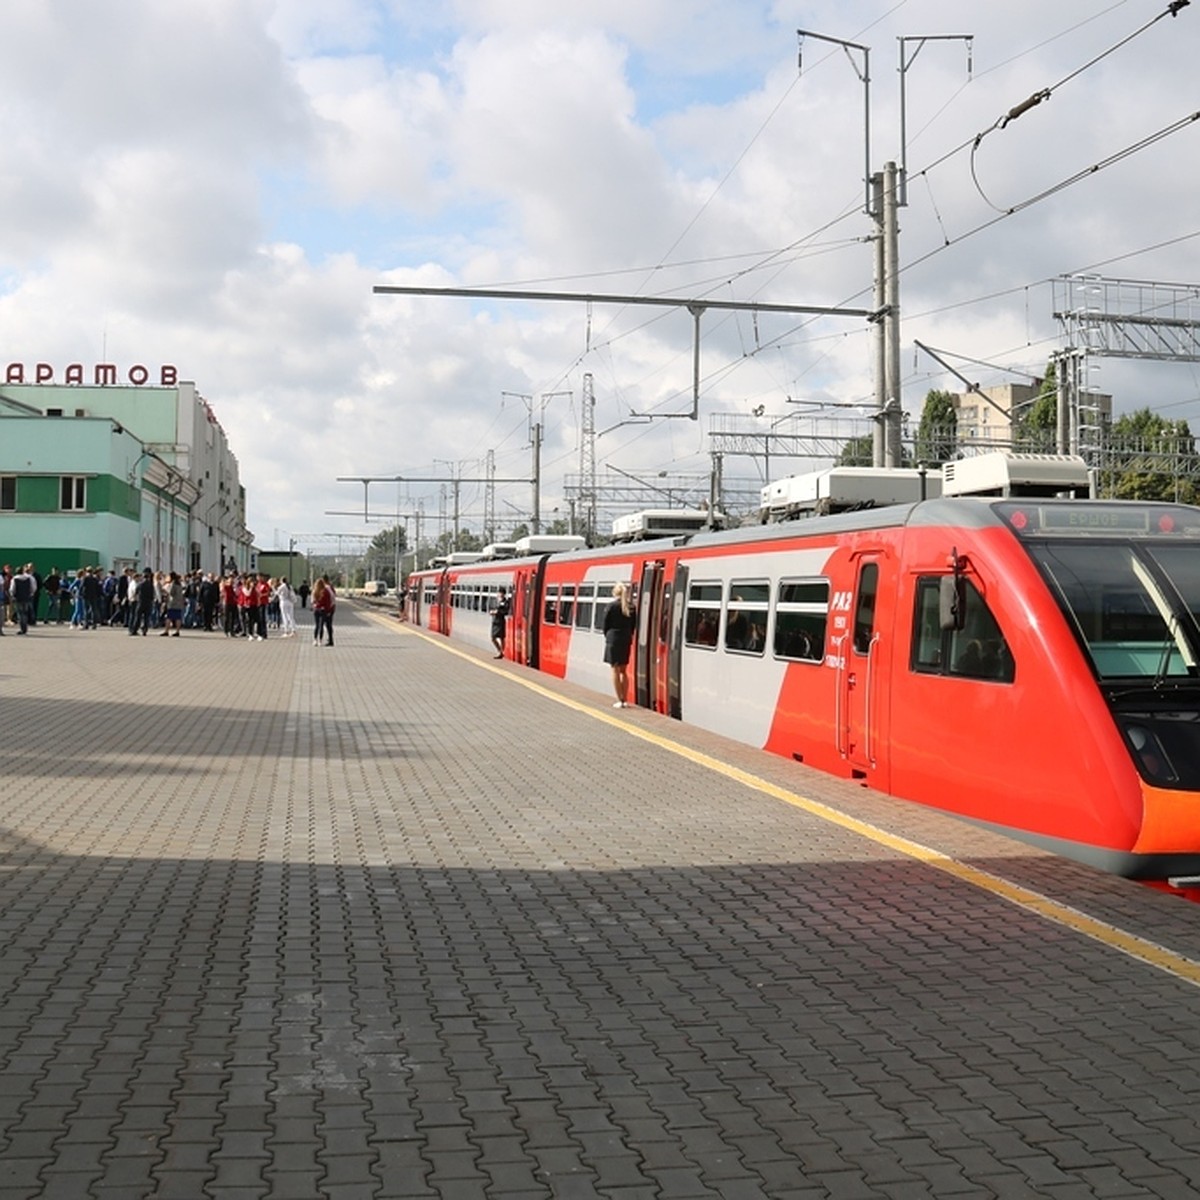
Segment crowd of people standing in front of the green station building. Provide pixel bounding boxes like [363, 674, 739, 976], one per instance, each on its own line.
[0, 563, 337, 646]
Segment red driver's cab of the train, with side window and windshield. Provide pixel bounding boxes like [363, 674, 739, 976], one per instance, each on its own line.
[888, 500, 1200, 878]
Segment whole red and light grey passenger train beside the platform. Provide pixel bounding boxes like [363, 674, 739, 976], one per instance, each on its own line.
[406, 489, 1200, 880]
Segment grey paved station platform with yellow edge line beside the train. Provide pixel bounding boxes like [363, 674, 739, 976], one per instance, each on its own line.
[0, 604, 1200, 1200]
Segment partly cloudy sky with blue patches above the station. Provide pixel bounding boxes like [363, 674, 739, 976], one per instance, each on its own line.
[0, 0, 1200, 548]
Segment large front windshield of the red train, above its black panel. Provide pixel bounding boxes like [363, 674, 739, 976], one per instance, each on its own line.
[1026, 539, 1200, 683]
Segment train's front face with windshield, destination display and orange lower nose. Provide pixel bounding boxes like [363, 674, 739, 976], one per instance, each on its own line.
[995, 502, 1200, 878]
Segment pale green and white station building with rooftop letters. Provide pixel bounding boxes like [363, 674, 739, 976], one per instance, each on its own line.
[0, 364, 253, 572]
